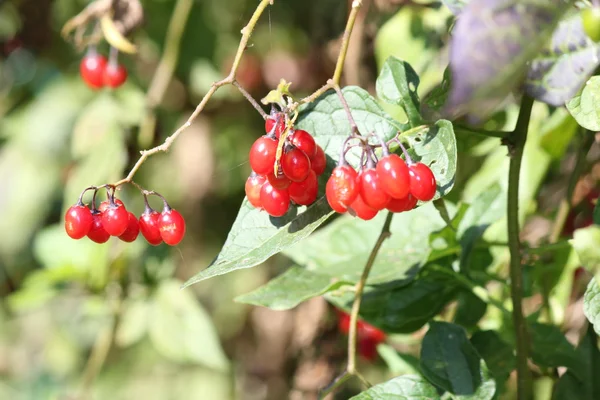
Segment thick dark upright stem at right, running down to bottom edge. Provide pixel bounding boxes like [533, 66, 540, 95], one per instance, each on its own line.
[507, 94, 533, 400]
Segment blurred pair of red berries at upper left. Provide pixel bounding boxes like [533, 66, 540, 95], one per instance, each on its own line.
[79, 49, 127, 89]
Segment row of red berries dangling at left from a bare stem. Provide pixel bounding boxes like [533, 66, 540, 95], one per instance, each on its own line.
[65, 187, 185, 246]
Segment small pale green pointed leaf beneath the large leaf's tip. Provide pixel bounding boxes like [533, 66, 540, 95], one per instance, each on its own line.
[235, 266, 345, 310]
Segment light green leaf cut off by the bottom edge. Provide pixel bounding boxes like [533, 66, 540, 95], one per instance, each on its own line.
[350, 375, 440, 400]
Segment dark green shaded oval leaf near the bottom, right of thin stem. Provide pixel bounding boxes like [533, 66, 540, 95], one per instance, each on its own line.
[421, 321, 482, 395]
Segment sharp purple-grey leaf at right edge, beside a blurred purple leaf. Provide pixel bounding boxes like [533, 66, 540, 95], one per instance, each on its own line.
[525, 15, 600, 106]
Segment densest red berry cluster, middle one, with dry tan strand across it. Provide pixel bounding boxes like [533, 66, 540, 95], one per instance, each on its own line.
[246, 113, 327, 217]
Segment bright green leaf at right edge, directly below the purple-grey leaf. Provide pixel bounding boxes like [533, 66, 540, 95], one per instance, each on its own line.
[567, 76, 600, 132]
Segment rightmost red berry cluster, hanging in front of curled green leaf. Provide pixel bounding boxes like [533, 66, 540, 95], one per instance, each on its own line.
[325, 139, 436, 220]
